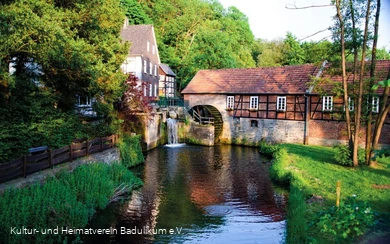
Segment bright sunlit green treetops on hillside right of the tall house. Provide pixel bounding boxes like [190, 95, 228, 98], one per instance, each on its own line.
[139, 0, 255, 87]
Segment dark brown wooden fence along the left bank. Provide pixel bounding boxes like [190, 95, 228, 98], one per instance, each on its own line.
[0, 135, 118, 183]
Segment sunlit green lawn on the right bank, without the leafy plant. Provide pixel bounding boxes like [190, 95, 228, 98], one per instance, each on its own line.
[271, 144, 390, 243]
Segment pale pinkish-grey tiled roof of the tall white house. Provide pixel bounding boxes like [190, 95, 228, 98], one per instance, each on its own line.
[121, 25, 160, 63]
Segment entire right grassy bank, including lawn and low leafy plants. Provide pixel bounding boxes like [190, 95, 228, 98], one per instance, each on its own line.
[261, 144, 390, 243]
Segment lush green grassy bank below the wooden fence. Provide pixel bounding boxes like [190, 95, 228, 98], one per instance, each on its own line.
[0, 136, 144, 243]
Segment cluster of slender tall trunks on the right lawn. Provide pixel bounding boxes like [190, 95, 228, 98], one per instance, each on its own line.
[335, 0, 388, 166]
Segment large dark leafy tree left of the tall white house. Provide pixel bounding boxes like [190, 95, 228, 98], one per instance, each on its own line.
[0, 0, 128, 161]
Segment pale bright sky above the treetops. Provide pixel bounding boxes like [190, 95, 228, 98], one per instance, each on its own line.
[219, 0, 390, 50]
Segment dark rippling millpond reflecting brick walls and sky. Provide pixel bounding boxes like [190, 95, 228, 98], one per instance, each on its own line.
[83, 145, 286, 243]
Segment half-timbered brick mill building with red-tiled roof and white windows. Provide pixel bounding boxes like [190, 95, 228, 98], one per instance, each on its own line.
[182, 60, 390, 145]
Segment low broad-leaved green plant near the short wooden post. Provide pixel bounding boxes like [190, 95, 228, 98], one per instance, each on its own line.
[317, 196, 375, 240]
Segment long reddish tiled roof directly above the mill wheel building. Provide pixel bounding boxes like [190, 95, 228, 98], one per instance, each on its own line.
[182, 64, 320, 94]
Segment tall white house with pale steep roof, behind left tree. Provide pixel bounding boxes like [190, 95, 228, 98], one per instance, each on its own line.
[121, 20, 160, 98]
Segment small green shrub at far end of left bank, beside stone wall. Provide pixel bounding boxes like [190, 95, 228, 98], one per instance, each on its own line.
[119, 134, 144, 167]
